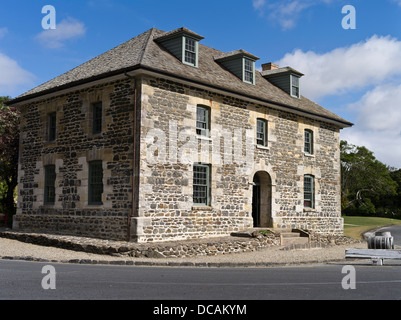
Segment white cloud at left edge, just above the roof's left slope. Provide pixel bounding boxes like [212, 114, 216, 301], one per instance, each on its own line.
[0, 52, 35, 96]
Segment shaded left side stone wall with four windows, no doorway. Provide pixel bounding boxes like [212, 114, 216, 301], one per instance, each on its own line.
[14, 80, 134, 240]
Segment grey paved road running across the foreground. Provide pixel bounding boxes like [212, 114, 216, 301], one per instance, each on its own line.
[0, 261, 401, 300]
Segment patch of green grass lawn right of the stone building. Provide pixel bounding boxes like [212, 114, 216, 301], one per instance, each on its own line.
[343, 216, 401, 239]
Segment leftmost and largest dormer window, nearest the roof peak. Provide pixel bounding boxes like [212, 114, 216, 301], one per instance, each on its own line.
[155, 28, 204, 67]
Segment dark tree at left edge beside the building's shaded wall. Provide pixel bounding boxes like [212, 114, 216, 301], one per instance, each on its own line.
[0, 97, 20, 222]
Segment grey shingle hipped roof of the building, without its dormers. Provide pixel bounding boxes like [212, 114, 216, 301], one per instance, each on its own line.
[11, 28, 352, 126]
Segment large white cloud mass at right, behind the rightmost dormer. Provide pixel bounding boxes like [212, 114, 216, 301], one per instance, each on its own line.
[277, 35, 401, 168]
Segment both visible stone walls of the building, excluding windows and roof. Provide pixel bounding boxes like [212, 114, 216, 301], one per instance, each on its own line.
[14, 72, 343, 242]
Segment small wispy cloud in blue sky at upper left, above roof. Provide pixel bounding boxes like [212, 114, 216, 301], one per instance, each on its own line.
[36, 18, 86, 49]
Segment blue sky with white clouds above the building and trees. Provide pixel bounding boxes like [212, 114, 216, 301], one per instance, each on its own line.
[0, 0, 401, 168]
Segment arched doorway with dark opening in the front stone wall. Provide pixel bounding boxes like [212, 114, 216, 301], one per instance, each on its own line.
[252, 171, 273, 228]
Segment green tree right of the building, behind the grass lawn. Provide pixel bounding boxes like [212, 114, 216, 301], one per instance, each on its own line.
[340, 141, 398, 215]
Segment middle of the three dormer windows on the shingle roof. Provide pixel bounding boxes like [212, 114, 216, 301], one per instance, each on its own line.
[214, 50, 259, 84]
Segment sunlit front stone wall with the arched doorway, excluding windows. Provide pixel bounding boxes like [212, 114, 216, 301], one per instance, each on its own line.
[133, 77, 343, 242]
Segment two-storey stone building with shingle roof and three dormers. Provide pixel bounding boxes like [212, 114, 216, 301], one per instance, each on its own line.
[10, 28, 352, 242]
